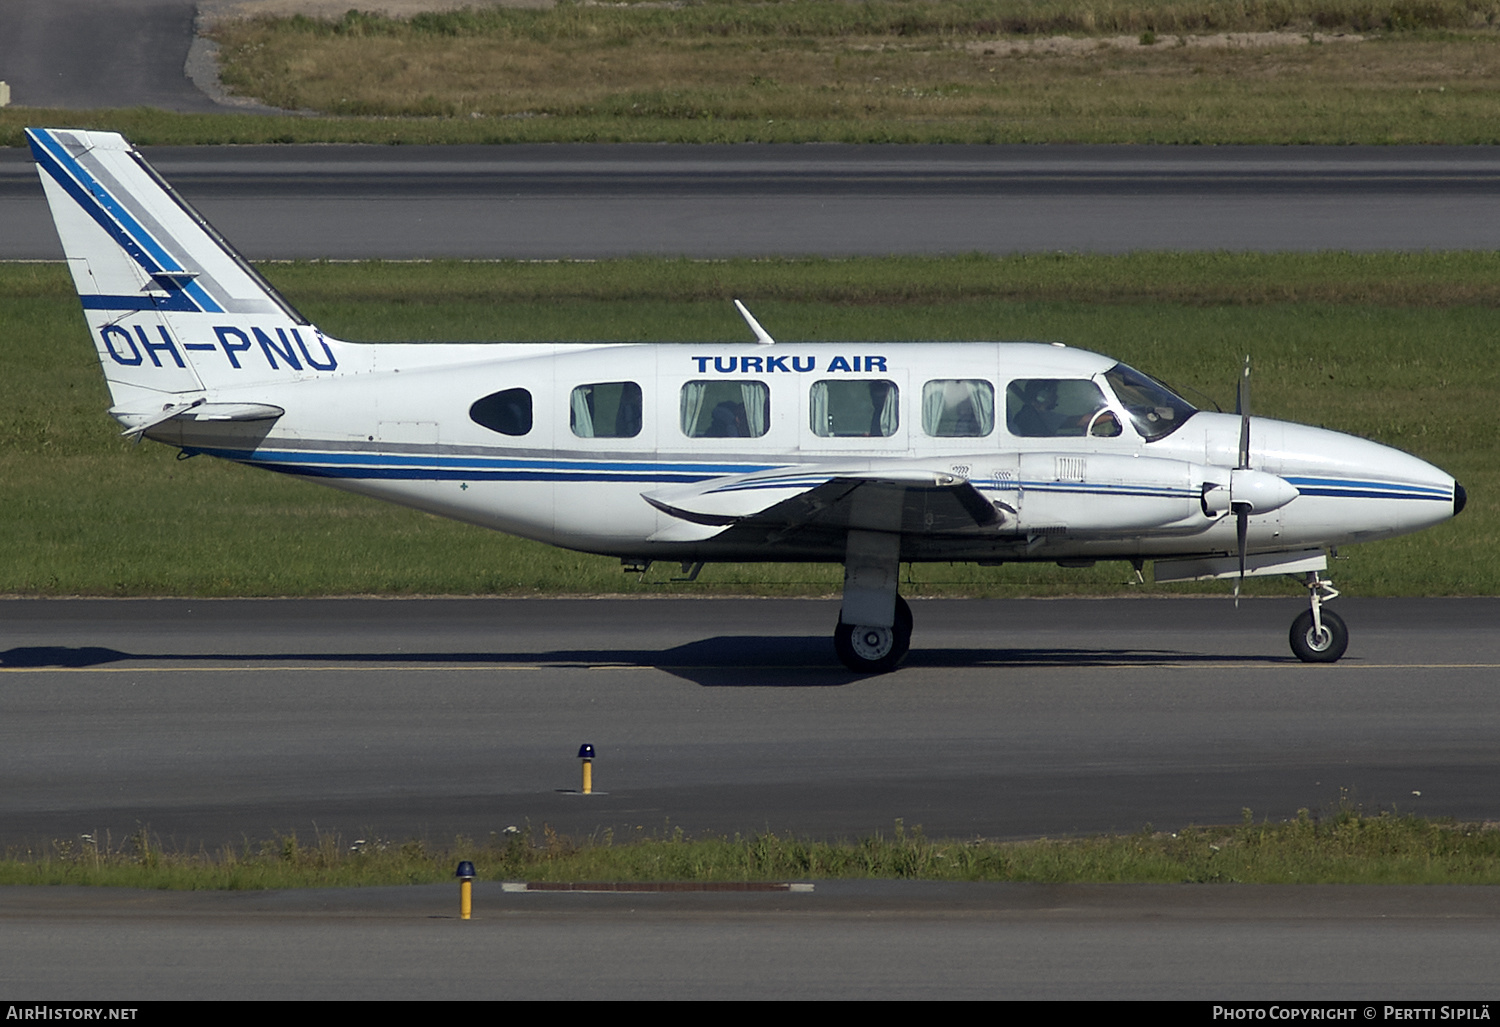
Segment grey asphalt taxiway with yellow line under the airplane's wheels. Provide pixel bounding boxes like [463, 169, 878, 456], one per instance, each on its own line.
[0, 598, 1500, 849]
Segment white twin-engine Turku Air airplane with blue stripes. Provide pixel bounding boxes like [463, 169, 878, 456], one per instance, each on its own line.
[27, 129, 1466, 673]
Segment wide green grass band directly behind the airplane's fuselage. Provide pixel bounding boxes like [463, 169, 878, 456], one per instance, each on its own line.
[0, 253, 1500, 597]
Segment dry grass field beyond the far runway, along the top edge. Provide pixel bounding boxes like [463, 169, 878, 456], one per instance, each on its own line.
[14, 0, 1500, 145]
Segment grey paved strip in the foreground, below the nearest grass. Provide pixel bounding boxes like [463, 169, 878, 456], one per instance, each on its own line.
[0, 882, 1500, 995]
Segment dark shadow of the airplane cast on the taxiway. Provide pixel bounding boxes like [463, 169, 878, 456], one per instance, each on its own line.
[0, 636, 1295, 688]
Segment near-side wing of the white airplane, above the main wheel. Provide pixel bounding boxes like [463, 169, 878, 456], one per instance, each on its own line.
[642, 465, 1005, 540]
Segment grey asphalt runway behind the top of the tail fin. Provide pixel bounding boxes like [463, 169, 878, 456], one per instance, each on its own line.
[0, 145, 1500, 259]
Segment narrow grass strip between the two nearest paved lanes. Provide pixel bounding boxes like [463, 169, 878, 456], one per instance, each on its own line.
[11, 808, 1500, 891]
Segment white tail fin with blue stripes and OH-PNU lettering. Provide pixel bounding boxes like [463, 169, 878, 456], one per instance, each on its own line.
[26, 129, 344, 424]
